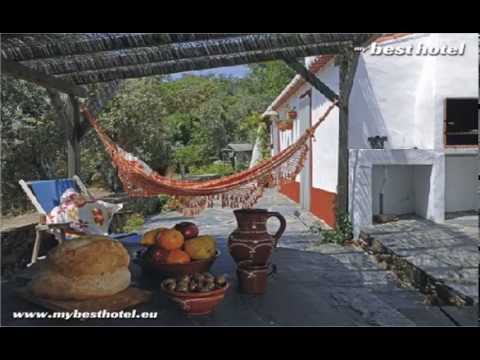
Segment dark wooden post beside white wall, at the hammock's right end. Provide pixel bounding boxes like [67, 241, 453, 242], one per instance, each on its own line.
[336, 49, 360, 219]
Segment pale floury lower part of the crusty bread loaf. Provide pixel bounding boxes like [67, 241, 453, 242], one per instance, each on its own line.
[30, 267, 130, 300]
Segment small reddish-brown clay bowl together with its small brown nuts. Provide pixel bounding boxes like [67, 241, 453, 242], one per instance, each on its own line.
[161, 272, 229, 315]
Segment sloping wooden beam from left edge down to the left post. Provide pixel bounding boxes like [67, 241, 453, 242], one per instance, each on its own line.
[1, 58, 88, 98]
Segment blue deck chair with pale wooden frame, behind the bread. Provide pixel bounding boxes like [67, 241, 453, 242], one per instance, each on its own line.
[19, 175, 140, 266]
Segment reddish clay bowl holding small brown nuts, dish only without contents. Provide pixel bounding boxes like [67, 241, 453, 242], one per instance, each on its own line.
[161, 282, 230, 315]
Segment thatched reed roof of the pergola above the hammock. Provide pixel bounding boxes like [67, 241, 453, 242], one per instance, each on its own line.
[1, 33, 372, 91]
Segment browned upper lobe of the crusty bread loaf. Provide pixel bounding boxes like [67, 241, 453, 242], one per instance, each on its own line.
[48, 236, 130, 277]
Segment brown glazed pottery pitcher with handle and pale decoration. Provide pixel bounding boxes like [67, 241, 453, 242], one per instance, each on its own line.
[228, 209, 287, 265]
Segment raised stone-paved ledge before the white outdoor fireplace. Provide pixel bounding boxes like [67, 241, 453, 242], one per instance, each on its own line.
[362, 214, 480, 304]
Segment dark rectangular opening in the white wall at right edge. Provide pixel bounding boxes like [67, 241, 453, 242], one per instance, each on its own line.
[445, 98, 478, 146]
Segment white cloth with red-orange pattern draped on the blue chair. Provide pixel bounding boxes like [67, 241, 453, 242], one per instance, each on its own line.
[47, 188, 122, 235]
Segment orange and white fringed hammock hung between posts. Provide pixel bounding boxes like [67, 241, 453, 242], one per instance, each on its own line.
[82, 103, 336, 216]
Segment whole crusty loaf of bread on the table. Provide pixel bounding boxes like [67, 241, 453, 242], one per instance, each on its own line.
[30, 236, 131, 300]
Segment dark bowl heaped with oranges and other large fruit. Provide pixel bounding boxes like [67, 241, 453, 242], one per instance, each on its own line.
[138, 222, 220, 277]
